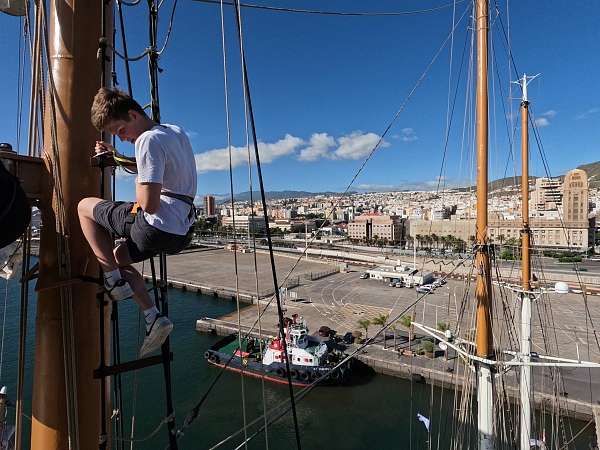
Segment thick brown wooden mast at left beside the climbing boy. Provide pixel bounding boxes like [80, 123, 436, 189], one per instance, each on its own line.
[31, 0, 112, 450]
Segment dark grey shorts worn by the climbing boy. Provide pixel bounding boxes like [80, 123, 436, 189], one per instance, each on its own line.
[94, 200, 186, 262]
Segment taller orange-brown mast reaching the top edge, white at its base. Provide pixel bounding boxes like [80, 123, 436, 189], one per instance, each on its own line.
[475, 0, 494, 450]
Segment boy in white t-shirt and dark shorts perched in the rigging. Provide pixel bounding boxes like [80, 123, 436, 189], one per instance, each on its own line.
[78, 88, 196, 357]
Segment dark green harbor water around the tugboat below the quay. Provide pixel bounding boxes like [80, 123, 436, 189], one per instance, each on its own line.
[0, 272, 594, 450]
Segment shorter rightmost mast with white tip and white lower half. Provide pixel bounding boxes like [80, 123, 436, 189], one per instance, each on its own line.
[515, 74, 539, 450]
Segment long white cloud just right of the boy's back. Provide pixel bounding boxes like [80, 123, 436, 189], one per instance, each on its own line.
[195, 134, 304, 173]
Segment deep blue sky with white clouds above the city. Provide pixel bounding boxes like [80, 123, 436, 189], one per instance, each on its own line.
[0, 0, 600, 199]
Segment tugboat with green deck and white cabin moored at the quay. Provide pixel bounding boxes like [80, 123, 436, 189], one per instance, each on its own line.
[204, 314, 352, 386]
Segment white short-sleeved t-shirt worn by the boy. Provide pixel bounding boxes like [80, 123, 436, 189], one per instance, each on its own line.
[135, 124, 196, 235]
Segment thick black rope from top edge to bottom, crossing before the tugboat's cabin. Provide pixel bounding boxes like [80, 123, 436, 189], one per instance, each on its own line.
[235, 0, 302, 450]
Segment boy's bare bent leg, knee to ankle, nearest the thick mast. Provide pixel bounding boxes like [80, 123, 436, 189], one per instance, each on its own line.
[77, 197, 117, 272]
